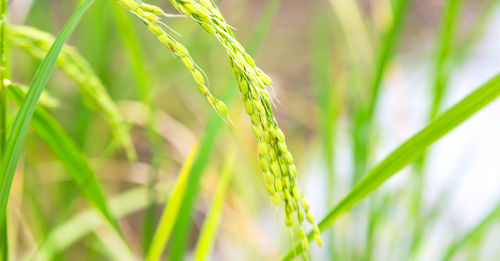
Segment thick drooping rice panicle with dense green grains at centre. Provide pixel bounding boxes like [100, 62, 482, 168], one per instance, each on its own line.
[170, 0, 322, 248]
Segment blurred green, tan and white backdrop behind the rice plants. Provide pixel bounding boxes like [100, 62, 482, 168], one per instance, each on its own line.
[6, 0, 500, 260]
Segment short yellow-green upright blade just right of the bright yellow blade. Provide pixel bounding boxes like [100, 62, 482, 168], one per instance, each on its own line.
[193, 153, 235, 261]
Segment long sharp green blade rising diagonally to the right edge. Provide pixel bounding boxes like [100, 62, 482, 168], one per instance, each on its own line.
[283, 74, 500, 260]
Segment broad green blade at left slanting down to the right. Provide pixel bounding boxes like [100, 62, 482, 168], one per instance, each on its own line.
[8, 84, 121, 233]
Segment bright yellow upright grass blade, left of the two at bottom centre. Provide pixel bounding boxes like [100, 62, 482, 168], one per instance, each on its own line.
[146, 144, 198, 261]
